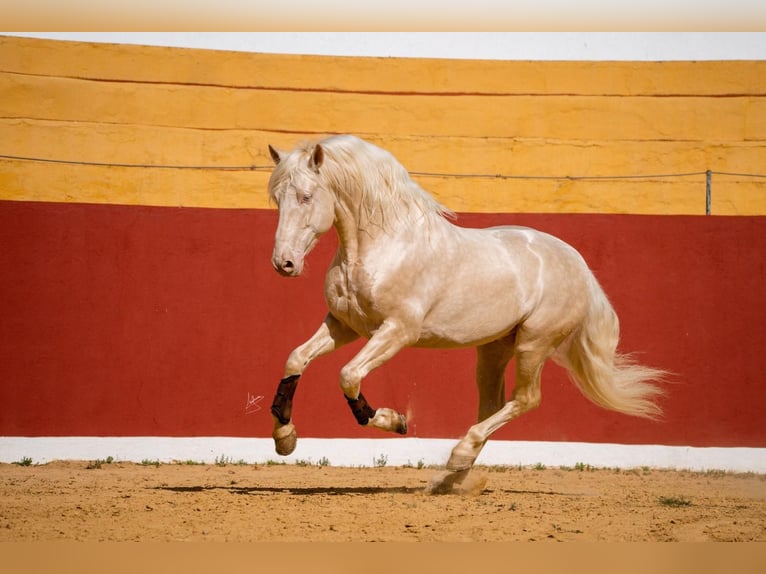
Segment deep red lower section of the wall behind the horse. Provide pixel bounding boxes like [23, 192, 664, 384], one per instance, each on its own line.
[0, 202, 766, 447]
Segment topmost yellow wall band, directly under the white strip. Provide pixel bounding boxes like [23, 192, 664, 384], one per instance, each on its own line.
[0, 36, 766, 96]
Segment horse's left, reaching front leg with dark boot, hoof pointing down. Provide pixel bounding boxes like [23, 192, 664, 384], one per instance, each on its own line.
[271, 314, 358, 456]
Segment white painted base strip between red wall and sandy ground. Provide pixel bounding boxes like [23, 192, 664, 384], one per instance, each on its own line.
[0, 437, 766, 473]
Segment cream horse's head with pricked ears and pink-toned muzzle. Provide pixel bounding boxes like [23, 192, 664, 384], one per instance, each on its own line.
[269, 144, 335, 277]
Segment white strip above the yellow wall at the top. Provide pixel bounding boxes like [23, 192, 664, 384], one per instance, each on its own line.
[2, 32, 766, 61]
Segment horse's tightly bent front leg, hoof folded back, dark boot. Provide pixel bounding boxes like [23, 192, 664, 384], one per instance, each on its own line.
[340, 319, 414, 434]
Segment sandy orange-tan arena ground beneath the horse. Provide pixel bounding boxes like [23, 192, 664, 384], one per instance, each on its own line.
[0, 461, 766, 542]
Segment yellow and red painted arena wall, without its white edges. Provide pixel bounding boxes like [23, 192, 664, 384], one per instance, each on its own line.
[0, 37, 766, 468]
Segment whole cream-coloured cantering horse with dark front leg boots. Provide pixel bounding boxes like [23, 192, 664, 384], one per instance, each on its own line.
[269, 135, 663, 492]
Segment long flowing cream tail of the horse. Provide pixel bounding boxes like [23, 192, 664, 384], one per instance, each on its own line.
[559, 277, 667, 419]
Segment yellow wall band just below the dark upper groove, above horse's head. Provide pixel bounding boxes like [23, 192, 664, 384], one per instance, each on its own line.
[0, 73, 766, 141]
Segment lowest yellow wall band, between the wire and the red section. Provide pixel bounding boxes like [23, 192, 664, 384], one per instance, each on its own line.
[0, 160, 766, 215]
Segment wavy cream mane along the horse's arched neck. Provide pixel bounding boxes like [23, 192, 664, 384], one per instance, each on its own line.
[275, 135, 455, 232]
